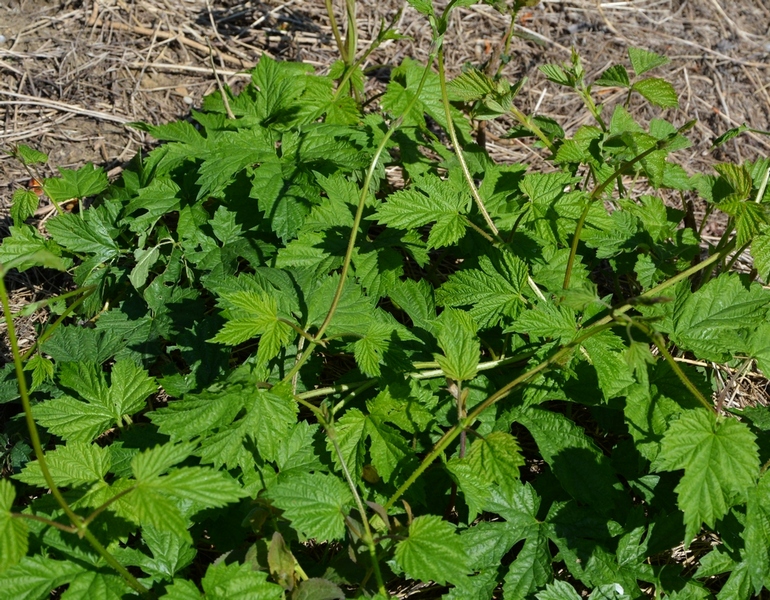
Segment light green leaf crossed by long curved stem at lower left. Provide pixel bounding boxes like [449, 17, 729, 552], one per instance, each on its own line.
[14, 442, 111, 487]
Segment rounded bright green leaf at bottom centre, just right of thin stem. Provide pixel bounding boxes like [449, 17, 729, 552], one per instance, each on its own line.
[396, 515, 471, 585]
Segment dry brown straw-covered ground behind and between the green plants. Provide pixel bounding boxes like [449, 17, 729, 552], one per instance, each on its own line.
[0, 0, 770, 404]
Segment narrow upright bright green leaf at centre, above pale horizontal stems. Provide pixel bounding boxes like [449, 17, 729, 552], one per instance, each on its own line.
[436, 308, 481, 381]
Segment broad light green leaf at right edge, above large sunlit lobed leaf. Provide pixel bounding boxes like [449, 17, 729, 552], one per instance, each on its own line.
[671, 274, 770, 362]
